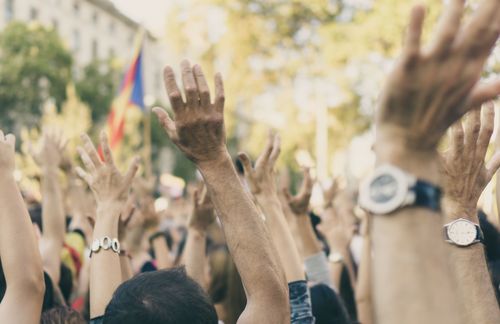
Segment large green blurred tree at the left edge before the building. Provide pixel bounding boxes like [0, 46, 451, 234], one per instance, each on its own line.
[0, 22, 72, 130]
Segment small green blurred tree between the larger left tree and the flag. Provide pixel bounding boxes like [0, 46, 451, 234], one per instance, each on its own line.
[75, 61, 121, 122]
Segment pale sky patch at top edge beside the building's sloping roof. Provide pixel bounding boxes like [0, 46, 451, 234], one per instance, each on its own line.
[111, 0, 174, 36]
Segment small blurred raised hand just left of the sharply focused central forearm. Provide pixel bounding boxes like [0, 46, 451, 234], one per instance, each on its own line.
[188, 185, 215, 232]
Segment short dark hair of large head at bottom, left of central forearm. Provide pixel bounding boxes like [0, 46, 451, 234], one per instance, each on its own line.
[104, 267, 217, 324]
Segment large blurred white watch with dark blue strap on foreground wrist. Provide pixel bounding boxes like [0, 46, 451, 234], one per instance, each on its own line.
[358, 164, 441, 215]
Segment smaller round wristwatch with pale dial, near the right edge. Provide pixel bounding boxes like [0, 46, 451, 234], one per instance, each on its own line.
[443, 218, 484, 247]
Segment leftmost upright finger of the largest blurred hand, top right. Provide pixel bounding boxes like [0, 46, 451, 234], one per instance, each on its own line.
[403, 5, 425, 66]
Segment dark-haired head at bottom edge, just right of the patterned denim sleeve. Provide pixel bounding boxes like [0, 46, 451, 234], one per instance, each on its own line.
[311, 284, 352, 324]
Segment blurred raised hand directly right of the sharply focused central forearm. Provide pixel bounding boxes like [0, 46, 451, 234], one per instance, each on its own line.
[238, 132, 281, 197]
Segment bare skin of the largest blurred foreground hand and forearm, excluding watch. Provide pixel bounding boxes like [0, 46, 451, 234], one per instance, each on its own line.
[372, 0, 500, 324]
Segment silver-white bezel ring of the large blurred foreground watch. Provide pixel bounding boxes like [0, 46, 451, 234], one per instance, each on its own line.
[359, 164, 417, 215]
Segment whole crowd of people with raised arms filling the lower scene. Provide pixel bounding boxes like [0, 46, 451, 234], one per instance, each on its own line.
[0, 0, 500, 324]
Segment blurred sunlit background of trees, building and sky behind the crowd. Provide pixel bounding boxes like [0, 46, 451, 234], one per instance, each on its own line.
[0, 0, 500, 220]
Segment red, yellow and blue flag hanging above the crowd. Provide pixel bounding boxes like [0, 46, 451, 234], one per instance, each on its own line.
[108, 31, 145, 149]
